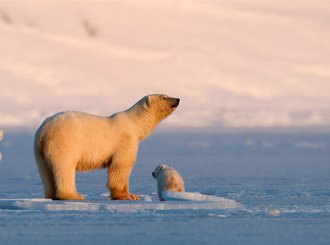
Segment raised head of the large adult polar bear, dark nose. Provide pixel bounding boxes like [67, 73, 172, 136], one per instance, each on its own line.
[142, 94, 180, 121]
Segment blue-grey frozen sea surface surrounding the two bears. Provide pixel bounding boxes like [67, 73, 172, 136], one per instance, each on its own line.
[0, 129, 330, 244]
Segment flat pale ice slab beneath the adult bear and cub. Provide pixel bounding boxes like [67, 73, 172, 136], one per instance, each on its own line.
[0, 193, 243, 212]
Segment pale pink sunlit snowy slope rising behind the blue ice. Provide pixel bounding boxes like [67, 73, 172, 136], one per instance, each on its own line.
[0, 0, 330, 129]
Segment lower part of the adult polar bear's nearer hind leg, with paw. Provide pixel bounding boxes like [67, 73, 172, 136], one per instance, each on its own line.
[53, 164, 85, 200]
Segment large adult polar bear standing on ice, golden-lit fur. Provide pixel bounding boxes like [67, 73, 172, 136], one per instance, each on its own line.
[34, 94, 180, 200]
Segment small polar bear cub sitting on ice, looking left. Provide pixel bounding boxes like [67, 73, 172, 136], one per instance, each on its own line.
[152, 164, 185, 201]
